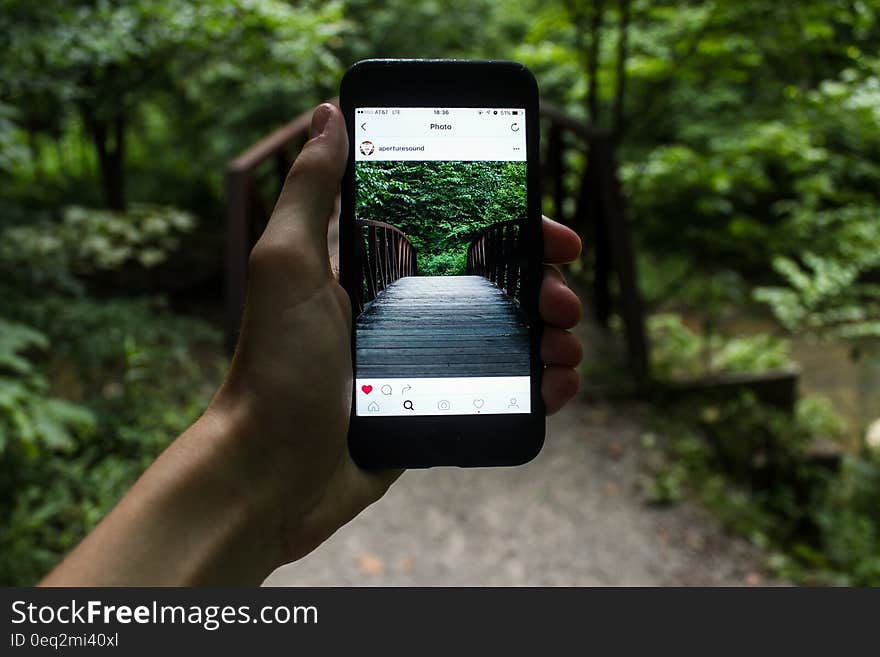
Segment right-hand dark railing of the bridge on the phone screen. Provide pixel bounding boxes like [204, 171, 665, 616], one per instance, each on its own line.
[467, 220, 523, 302]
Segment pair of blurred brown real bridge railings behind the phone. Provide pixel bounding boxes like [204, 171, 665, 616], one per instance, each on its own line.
[225, 101, 648, 382]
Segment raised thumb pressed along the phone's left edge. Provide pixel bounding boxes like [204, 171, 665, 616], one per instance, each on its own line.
[255, 103, 348, 280]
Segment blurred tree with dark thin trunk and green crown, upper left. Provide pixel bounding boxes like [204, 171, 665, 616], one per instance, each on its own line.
[0, 0, 340, 210]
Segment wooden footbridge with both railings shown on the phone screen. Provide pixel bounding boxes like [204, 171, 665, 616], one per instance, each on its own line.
[355, 221, 529, 378]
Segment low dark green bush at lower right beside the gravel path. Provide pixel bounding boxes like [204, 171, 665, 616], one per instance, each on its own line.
[643, 394, 880, 586]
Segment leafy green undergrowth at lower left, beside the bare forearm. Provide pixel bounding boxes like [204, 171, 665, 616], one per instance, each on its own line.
[0, 297, 221, 585]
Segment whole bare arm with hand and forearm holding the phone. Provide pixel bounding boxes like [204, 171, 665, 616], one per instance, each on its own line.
[43, 105, 581, 586]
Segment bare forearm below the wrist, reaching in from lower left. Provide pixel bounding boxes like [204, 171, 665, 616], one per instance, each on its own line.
[42, 410, 283, 586]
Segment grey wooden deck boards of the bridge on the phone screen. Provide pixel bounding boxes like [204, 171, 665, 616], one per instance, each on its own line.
[356, 276, 529, 378]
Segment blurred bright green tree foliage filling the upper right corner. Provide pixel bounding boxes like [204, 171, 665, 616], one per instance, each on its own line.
[502, 0, 880, 306]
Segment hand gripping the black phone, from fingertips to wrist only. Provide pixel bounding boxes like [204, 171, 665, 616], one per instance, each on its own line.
[216, 104, 581, 560]
